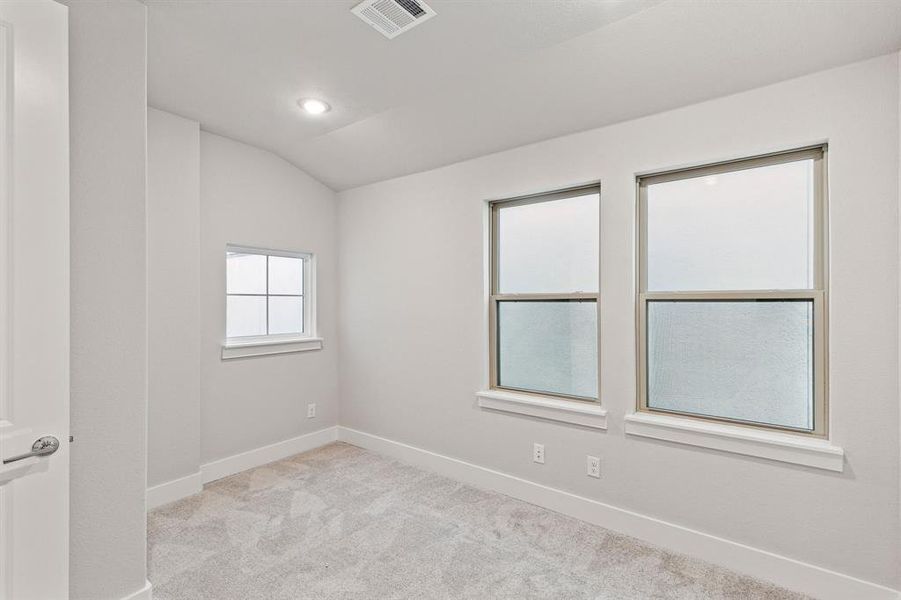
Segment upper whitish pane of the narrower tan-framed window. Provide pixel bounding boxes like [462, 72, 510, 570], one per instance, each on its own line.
[497, 194, 599, 294]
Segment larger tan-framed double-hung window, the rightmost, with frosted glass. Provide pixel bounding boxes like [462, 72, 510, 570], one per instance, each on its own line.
[638, 147, 828, 436]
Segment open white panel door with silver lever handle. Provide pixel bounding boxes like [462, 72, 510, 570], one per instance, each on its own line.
[0, 0, 69, 600]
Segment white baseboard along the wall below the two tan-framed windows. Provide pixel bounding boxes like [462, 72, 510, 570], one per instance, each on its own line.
[338, 426, 901, 600]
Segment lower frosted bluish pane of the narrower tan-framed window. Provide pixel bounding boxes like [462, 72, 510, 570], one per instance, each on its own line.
[497, 301, 598, 398]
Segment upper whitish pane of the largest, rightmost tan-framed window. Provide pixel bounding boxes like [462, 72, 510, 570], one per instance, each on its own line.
[647, 160, 814, 291]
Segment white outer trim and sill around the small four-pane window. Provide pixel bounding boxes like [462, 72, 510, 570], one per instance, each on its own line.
[222, 244, 323, 360]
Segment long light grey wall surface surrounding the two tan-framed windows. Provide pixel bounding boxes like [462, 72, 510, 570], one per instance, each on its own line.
[339, 55, 901, 588]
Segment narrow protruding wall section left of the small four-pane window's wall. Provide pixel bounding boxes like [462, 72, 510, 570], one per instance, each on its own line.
[147, 108, 201, 486]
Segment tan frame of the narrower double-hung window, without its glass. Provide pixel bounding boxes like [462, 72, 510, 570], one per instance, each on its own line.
[488, 182, 601, 404]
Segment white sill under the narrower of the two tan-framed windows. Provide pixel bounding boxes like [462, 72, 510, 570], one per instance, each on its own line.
[476, 390, 607, 429]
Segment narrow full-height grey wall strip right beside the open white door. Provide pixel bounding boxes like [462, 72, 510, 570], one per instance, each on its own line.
[66, 0, 147, 600]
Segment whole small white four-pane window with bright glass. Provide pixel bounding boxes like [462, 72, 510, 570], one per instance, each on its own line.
[223, 245, 321, 358]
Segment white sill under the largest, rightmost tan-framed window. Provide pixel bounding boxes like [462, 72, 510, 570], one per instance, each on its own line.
[625, 413, 845, 472]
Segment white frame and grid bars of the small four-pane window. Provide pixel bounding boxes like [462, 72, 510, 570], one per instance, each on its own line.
[223, 244, 318, 348]
